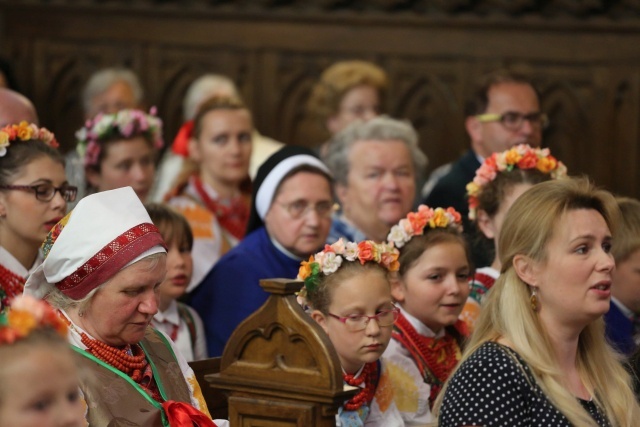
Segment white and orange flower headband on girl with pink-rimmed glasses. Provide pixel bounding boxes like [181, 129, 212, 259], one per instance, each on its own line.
[298, 238, 400, 292]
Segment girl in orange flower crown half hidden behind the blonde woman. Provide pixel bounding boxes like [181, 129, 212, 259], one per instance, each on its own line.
[461, 144, 567, 331]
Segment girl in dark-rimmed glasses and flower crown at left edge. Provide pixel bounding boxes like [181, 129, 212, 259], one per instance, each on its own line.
[0, 122, 77, 310]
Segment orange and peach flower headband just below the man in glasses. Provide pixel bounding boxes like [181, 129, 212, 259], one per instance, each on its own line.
[467, 144, 567, 220]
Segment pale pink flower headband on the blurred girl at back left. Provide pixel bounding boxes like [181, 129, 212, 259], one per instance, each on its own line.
[76, 107, 164, 166]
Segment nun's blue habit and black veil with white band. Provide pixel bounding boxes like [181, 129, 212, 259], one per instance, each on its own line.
[191, 146, 328, 357]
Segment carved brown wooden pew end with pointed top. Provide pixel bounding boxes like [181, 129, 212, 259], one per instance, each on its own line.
[192, 279, 357, 427]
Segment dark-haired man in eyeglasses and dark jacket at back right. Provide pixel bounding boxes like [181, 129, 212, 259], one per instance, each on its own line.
[422, 70, 548, 265]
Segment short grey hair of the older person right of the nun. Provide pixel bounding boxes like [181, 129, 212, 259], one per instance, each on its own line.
[323, 116, 427, 185]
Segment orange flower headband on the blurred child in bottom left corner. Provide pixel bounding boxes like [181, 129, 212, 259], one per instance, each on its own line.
[0, 295, 67, 345]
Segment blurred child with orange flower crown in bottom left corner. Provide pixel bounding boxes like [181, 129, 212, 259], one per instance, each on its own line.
[0, 296, 86, 427]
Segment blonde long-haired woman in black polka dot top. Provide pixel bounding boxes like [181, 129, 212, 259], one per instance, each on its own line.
[434, 179, 640, 427]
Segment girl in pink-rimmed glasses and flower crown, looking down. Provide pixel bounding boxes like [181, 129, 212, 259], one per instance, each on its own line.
[298, 239, 404, 427]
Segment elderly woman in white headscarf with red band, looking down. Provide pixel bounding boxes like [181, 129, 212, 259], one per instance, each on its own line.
[25, 187, 226, 427]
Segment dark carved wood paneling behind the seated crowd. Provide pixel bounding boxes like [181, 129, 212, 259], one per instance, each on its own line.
[0, 0, 640, 197]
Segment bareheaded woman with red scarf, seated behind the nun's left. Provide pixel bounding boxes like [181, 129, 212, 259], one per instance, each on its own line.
[166, 96, 253, 292]
